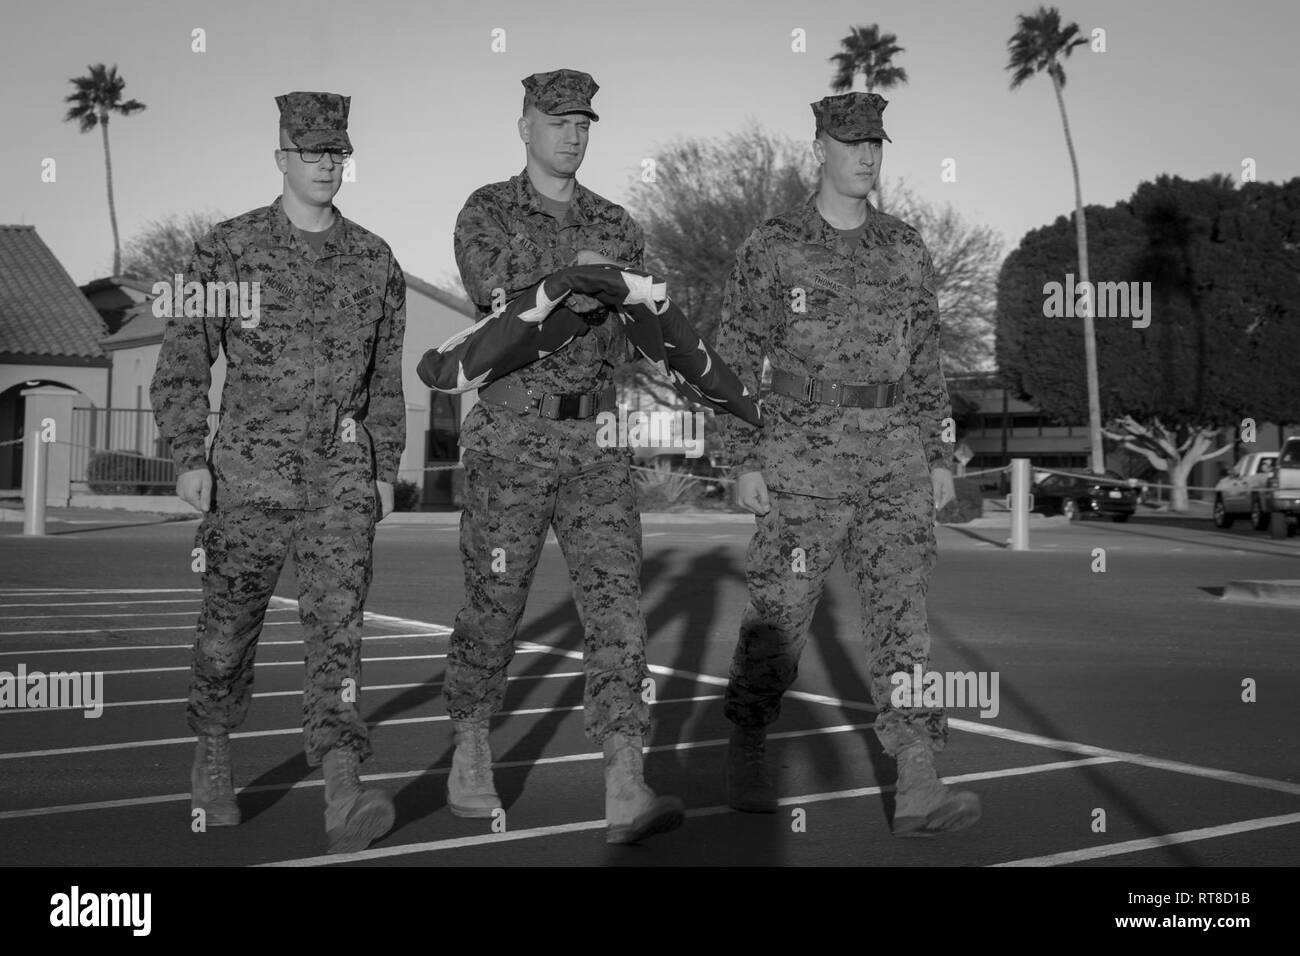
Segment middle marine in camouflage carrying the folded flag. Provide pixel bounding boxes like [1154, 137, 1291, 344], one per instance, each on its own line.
[446, 70, 681, 843]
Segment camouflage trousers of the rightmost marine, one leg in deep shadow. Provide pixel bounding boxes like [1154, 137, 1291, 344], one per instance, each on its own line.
[725, 468, 948, 756]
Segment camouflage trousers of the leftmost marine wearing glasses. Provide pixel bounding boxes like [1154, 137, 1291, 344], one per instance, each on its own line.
[189, 502, 374, 766]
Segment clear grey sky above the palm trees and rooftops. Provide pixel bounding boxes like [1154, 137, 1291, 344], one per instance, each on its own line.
[0, 0, 1300, 291]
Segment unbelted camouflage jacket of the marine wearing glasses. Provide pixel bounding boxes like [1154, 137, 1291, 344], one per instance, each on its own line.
[150, 193, 406, 509]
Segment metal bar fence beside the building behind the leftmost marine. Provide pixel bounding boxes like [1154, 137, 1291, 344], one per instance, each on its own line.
[69, 408, 218, 494]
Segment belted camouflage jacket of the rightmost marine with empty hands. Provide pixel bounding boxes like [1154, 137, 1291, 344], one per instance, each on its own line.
[718, 196, 952, 498]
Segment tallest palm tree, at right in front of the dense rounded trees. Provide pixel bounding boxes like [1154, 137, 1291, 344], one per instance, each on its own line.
[1006, 7, 1105, 475]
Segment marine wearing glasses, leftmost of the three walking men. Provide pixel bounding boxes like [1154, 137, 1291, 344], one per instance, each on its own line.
[151, 92, 406, 851]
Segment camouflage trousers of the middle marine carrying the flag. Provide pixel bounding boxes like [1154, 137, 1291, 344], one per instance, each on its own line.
[446, 451, 650, 744]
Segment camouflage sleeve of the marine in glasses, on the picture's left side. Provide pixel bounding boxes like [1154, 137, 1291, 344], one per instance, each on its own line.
[150, 233, 227, 473]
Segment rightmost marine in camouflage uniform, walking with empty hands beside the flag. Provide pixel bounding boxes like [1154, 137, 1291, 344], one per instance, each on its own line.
[718, 94, 979, 834]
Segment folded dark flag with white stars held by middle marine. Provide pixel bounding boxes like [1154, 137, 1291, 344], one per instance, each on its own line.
[417, 265, 761, 425]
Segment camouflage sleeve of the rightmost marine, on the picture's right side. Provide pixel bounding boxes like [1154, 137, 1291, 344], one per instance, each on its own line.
[902, 246, 953, 468]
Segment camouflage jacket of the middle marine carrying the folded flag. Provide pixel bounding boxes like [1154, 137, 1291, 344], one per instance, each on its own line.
[454, 170, 645, 468]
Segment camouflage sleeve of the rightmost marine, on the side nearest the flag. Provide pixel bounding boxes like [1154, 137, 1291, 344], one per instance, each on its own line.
[714, 235, 784, 477]
